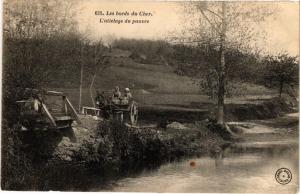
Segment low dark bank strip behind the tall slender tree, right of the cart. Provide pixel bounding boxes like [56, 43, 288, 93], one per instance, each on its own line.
[139, 95, 298, 123]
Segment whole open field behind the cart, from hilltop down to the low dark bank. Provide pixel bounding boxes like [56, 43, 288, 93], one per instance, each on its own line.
[44, 49, 288, 122]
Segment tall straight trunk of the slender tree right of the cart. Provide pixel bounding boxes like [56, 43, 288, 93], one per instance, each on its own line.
[217, 2, 226, 125]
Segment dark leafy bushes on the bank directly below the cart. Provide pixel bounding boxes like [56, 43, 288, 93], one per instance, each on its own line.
[76, 122, 174, 172]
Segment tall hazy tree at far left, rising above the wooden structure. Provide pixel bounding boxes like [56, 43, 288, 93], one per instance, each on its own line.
[3, 0, 76, 125]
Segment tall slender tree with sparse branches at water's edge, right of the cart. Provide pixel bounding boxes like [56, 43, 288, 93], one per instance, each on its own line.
[180, 1, 273, 125]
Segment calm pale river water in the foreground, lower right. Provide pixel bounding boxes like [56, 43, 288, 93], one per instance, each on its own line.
[100, 115, 299, 193]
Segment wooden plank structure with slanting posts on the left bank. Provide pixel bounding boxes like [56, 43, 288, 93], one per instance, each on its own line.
[17, 89, 80, 129]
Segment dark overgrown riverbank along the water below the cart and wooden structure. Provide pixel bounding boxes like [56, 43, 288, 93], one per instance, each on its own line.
[2, 96, 298, 191]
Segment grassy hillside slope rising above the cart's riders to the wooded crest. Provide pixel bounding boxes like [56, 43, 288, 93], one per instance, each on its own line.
[86, 49, 199, 93]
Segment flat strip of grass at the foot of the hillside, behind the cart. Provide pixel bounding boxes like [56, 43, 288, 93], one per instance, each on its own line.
[50, 85, 274, 111]
